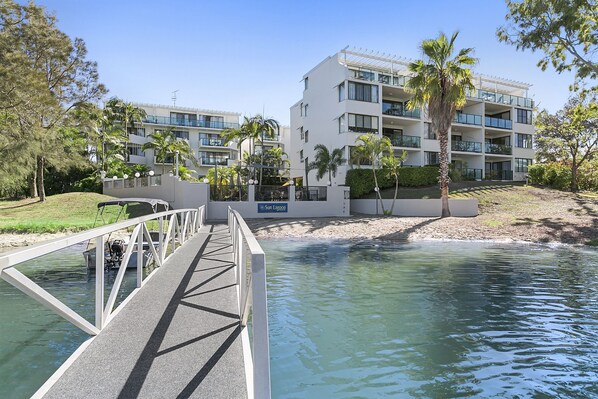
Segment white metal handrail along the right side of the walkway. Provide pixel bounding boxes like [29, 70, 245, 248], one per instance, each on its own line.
[228, 206, 271, 399]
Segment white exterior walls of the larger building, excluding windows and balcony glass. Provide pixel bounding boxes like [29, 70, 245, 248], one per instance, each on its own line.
[291, 50, 534, 185]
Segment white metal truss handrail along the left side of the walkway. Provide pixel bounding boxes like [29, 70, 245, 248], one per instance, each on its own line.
[0, 209, 206, 335]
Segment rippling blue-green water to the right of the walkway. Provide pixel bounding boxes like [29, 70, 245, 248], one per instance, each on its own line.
[261, 240, 598, 399]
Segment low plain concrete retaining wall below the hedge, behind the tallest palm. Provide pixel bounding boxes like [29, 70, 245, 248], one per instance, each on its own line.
[351, 199, 478, 217]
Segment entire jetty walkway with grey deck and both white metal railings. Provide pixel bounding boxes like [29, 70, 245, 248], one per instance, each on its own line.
[0, 206, 270, 399]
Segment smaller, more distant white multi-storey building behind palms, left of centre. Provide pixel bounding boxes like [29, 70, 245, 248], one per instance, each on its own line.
[127, 103, 290, 176]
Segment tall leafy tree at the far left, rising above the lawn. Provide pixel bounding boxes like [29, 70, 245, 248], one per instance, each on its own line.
[0, 0, 105, 201]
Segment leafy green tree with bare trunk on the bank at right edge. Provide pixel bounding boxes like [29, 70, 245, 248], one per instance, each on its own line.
[535, 95, 598, 191]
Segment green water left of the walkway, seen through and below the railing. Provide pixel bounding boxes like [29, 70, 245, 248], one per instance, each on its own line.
[0, 245, 136, 399]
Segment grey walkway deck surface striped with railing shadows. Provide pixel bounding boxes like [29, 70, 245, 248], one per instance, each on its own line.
[44, 225, 247, 399]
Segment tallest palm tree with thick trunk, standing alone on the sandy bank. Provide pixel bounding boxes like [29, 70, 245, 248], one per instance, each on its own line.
[406, 32, 477, 217]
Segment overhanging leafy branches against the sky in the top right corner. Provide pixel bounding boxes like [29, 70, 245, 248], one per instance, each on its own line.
[497, 0, 598, 86]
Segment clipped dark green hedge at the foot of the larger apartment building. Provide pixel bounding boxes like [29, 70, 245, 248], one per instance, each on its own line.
[345, 166, 439, 198]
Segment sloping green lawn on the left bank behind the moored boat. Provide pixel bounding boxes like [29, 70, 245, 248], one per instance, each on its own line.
[0, 193, 157, 233]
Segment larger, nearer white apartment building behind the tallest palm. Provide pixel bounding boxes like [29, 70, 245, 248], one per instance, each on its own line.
[289, 48, 534, 185]
